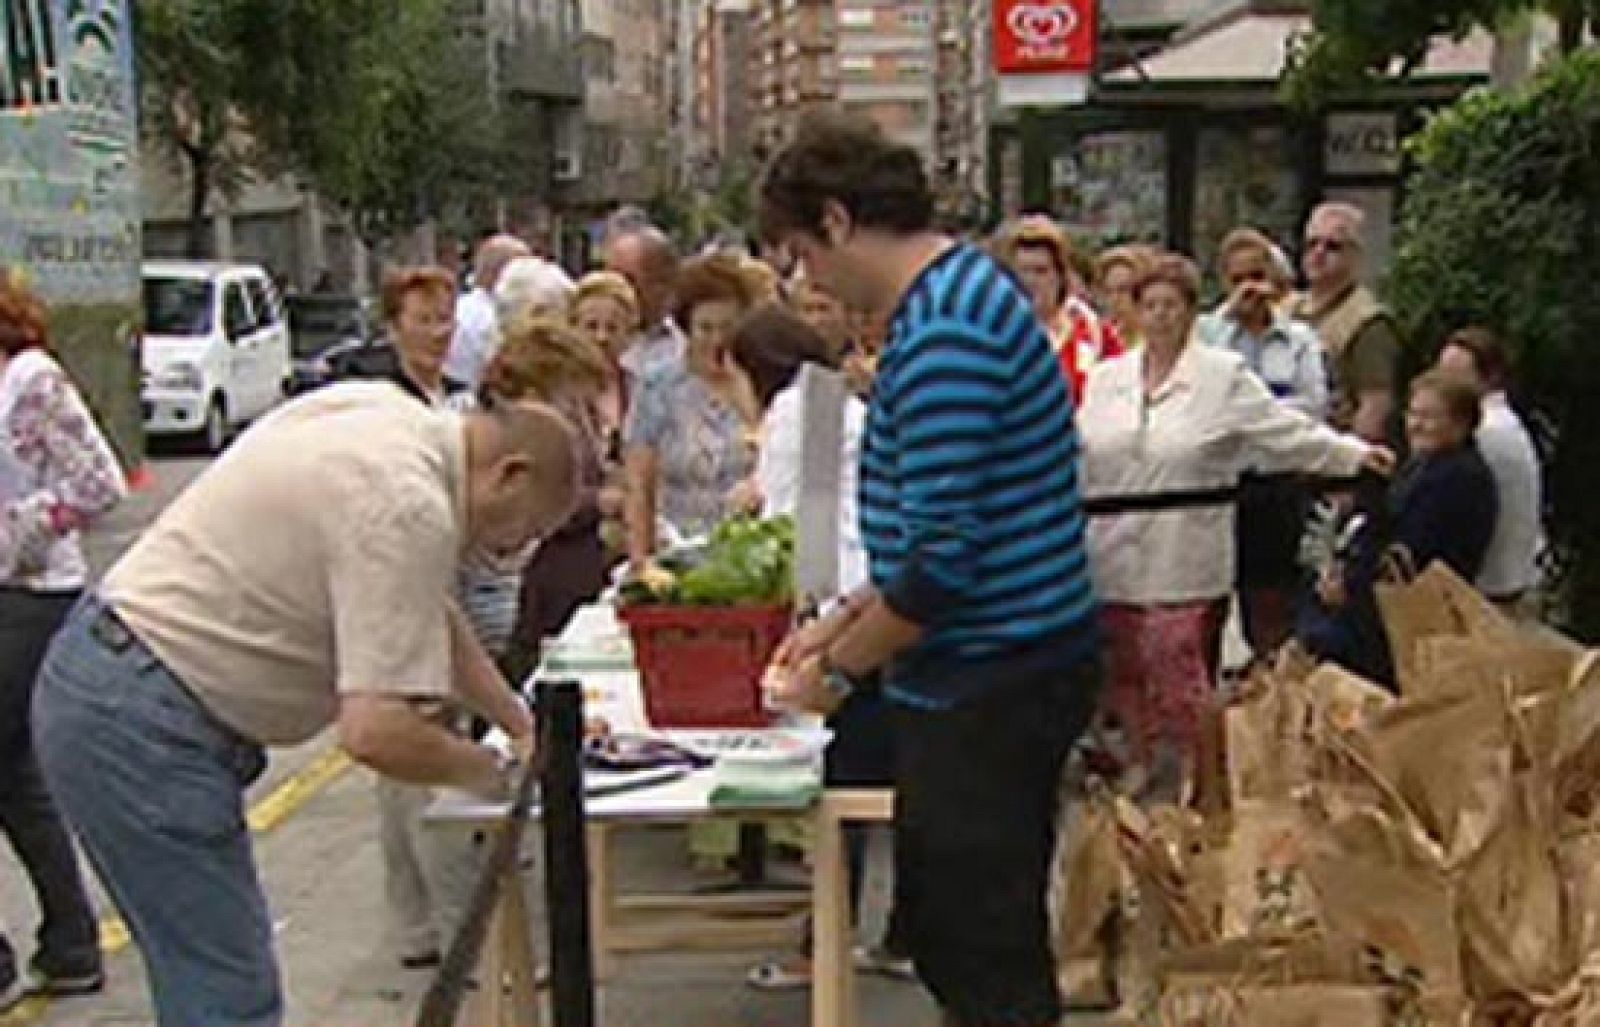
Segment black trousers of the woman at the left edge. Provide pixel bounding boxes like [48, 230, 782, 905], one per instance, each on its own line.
[0, 589, 101, 985]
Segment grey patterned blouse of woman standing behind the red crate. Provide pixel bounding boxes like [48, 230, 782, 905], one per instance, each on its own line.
[626, 365, 752, 537]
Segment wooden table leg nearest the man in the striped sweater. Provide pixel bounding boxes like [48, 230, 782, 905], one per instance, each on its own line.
[811, 795, 856, 1027]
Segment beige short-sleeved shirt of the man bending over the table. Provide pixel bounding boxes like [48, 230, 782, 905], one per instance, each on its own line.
[101, 382, 466, 744]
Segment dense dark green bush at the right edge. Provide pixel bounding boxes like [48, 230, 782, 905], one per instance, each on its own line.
[1389, 51, 1600, 638]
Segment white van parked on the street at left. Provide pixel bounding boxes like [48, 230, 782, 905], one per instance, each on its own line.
[141, 261, 291, 453]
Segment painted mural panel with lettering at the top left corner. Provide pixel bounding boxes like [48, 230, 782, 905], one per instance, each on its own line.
[0, 0, 141, 459]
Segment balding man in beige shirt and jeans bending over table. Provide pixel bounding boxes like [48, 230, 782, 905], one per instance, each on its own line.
[34, 382, 578, 1027]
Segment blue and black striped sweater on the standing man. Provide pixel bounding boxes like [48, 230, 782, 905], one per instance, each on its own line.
[861, 245, 1098, 707]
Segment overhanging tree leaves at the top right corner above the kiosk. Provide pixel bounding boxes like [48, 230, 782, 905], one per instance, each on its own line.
[1285, 0, 1600, 109]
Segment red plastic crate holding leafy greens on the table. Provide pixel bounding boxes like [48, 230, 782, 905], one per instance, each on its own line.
[618, 606, 794, 728]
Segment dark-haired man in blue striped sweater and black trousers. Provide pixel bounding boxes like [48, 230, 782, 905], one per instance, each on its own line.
[762, 114, 1098, 1025]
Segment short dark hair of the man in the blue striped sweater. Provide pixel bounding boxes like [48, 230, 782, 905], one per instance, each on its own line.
[760, 110, 933, 240]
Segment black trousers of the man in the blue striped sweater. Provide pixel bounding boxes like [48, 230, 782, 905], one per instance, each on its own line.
[893, 659, 1101, 1027]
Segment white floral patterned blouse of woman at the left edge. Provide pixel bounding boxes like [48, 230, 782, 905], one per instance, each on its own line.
[0, 349, 126, 592]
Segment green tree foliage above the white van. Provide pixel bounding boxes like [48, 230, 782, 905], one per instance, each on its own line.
[138, 0, 506, 256]
